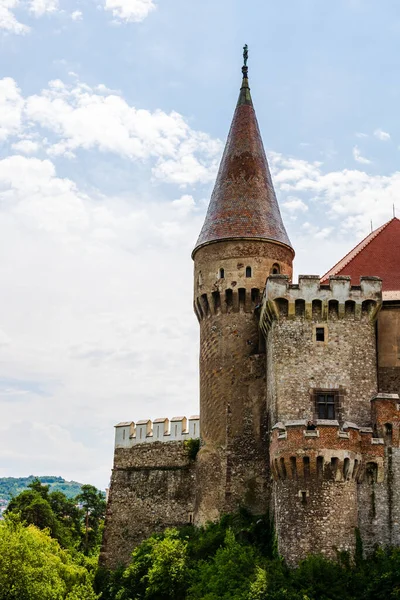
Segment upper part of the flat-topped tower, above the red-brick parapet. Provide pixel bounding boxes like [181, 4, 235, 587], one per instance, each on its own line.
[261, 276, 380, 426]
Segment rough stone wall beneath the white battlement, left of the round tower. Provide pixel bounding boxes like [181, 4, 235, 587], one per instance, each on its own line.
[100, 442, 195, 568]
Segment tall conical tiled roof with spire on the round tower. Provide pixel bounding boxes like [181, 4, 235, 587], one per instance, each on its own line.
[193, 53, 294, 255]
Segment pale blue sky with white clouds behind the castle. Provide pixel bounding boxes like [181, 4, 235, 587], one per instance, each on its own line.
[0, 0, 400, 488]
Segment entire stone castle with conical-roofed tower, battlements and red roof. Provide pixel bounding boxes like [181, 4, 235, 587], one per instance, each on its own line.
[101, 56, 400, 568]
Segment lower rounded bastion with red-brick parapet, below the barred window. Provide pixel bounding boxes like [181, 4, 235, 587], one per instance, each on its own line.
[270, 421, 385, 564]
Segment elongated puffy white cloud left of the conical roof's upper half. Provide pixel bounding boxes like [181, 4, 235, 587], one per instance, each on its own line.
[21, 80, 222, 186]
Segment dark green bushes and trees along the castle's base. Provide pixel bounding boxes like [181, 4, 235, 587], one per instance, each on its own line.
[95, 511, 400, 600]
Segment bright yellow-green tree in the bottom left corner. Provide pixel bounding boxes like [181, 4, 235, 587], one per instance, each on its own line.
[0, 517, 98, 600]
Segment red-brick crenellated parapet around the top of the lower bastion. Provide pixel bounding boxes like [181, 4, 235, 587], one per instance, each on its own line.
[270, 420, 385, 483]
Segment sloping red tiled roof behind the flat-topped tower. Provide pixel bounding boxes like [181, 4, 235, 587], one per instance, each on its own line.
[321, 217, 400, 291]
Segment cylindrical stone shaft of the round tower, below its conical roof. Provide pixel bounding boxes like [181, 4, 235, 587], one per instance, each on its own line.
[194, 240, 293, 524]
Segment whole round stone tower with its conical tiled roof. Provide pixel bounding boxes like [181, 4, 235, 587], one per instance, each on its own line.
[192, 56, 294, 524]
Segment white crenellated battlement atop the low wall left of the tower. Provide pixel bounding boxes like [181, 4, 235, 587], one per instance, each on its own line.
[115, 415, 200, 448]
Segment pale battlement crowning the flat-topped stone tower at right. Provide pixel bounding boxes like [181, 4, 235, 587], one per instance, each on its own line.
[260, 275, 382, 330]
